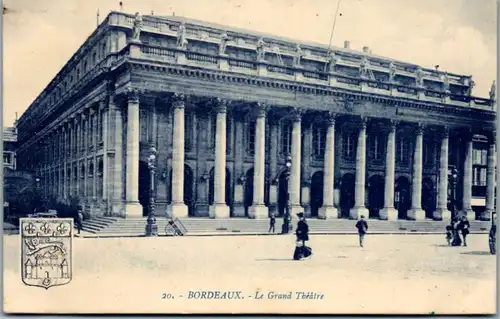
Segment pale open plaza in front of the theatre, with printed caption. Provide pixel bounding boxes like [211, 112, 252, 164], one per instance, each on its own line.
[4, 235, 496, 314]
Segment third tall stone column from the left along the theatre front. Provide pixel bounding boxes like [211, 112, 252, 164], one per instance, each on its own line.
[209, 99, 229, 218]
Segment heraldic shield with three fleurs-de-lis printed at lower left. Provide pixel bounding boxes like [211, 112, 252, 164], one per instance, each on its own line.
[19, 218, 73, 289]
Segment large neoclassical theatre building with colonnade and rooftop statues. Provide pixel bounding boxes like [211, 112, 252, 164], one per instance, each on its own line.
[18, 12, 496, 220]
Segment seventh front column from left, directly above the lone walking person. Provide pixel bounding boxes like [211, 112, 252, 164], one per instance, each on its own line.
[349, 118, 368, 219]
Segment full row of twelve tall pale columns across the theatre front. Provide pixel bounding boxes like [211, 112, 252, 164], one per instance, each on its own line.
[121, 95, 495, 220]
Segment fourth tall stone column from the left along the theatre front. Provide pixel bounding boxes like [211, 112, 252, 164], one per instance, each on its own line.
[248, 103, 268, 218]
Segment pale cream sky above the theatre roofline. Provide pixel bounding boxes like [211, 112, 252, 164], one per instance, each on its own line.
[3, 0, 497, 126]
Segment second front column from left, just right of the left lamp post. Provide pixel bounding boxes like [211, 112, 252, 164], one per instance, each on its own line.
[167, 94, 188, 218]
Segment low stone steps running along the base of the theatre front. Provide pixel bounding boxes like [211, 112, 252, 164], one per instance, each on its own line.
[79, 217, 491, 236]
